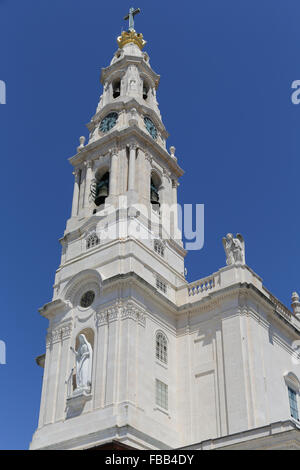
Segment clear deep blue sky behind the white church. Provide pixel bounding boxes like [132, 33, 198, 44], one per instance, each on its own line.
[0, 0, 300, 449]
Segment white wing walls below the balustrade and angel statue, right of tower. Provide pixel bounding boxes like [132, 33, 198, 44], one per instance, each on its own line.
[177, 293, 300, 443]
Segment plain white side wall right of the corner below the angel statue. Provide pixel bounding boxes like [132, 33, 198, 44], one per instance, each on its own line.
[246, 309, 300, 426]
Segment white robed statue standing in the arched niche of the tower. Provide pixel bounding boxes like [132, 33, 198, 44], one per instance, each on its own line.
[71, 334, 93, 393]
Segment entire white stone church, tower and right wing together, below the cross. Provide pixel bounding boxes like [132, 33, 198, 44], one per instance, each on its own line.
[30, 19, 300, 450]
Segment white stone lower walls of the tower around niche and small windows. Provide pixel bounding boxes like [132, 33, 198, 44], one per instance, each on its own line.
[32, 284, 180, 448]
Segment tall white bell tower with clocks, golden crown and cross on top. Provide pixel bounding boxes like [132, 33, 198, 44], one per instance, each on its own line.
[31, 9, 186, 449]
